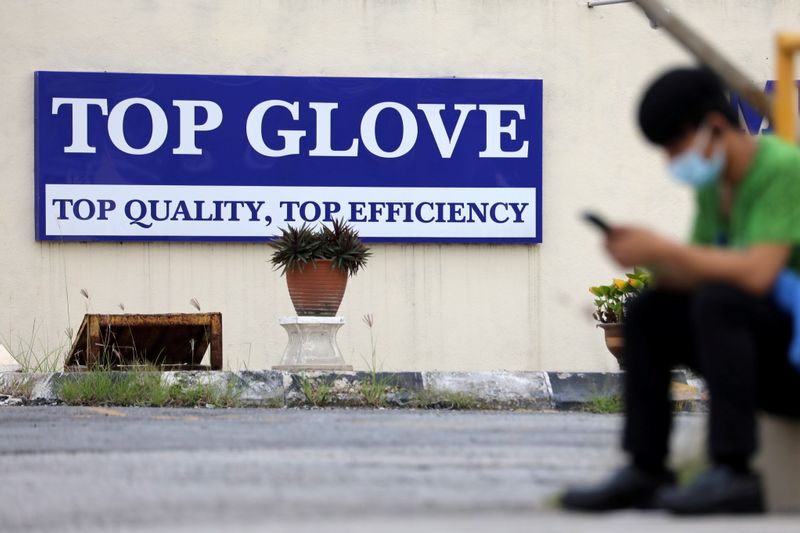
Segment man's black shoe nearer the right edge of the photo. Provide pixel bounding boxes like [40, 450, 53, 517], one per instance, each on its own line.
[655, 466, 764, 515]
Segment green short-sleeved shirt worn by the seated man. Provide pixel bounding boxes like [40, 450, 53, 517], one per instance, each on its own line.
[692, 136, 800, 271]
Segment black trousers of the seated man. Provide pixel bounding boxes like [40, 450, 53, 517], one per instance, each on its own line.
[623, 284, 800, 462]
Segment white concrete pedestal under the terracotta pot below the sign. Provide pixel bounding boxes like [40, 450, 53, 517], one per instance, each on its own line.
[272, 316, 353, 372]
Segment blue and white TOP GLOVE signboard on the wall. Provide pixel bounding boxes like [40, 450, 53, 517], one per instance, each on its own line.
[35, 72, 542, 243]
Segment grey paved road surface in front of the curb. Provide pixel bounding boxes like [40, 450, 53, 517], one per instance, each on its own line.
[0, 407, 800, 533]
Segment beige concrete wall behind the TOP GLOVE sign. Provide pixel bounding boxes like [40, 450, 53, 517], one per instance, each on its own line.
[0, 0, 800, 370]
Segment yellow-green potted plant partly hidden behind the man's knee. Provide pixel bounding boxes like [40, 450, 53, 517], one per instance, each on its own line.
[589, 267, 651, 369]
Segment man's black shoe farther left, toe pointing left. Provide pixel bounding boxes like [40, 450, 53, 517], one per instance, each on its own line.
[561, 465, 675, 512]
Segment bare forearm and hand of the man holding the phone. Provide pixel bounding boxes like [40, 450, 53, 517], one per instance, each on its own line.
[606, 227, 791, 296]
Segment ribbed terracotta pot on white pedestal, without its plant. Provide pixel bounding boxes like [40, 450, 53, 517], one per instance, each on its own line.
[286, 260, 347, 316]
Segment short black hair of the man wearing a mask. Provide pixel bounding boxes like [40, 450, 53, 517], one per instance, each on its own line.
[639, 68, 739, 146]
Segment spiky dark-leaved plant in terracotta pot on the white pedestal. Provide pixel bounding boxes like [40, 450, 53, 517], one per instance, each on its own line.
[270, 220, 371, 316]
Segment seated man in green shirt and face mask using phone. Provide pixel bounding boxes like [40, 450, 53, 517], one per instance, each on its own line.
[562, 65, 800, 514]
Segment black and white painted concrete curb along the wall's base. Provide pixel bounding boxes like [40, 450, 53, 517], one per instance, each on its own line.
[0, 370, 707, 411]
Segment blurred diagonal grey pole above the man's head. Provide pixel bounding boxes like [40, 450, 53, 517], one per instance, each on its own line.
[633, 0, 772, 121]
